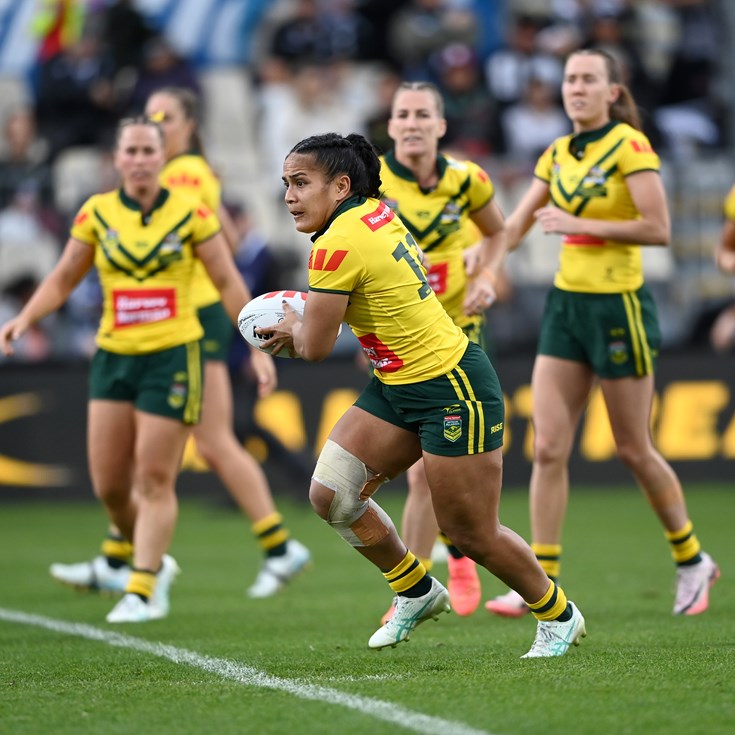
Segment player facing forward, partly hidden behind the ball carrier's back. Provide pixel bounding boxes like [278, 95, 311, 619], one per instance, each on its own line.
[380, 82, 504, 622]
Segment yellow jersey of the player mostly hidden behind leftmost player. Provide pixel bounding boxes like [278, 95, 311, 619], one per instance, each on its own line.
[164, 153, 222, 309]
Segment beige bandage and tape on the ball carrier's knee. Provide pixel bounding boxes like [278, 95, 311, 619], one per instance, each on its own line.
[314, 439, 394, 547]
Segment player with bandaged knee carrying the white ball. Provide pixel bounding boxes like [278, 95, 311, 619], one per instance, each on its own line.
[258, 133, 585, 658]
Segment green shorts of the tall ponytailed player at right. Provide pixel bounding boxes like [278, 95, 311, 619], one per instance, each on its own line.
[538, 286, 661, 378]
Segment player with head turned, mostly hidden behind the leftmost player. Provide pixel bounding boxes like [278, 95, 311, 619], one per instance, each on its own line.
[51, 87, 311, 598]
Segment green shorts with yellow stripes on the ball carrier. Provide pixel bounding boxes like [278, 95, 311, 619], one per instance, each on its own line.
[355, 342, 505, 457]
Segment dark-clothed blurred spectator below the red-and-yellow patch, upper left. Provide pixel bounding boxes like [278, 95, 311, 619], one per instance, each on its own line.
[36, 33, 116, 163]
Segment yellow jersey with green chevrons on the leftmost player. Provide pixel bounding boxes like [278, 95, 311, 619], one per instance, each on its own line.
[70, 189, 220, 355]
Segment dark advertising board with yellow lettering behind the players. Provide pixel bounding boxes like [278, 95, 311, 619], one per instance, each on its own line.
[0, 351, 735, 502]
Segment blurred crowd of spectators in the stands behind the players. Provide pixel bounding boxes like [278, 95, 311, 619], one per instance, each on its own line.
[0, 0, 735, 360]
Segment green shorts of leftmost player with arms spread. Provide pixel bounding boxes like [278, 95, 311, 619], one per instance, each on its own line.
[89, 341, 202, 424]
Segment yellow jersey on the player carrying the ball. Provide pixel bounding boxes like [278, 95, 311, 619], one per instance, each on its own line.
[309, 197, 468, 385]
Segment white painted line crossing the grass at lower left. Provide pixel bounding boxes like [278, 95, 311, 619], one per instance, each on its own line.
[0, 607, 493, 735]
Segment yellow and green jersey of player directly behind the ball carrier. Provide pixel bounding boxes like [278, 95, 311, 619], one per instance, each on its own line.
[380, 153, 495, 327]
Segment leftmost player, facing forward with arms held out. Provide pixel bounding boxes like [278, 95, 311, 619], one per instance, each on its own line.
[0, 117, 276, 623]
